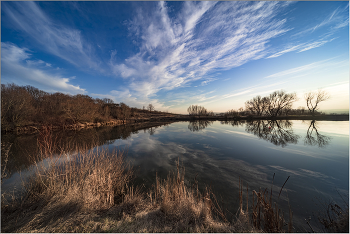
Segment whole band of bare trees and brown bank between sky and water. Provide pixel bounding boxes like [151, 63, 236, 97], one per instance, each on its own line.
[1, 84, 349, 134]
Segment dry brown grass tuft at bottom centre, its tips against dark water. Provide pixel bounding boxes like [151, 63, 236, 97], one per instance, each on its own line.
[142, 160, 234, 232]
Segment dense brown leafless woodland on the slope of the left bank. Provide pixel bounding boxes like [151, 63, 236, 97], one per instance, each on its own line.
[1, 84, 159, 131]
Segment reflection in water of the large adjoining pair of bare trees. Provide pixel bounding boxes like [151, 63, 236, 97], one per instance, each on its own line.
[245, 120, 299, 147]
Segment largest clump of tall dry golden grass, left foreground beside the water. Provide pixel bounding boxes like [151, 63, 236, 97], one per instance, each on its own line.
[26, 128, 132, 209]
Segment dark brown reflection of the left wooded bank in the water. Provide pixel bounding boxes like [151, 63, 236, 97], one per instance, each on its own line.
[1, 122, 172, 176]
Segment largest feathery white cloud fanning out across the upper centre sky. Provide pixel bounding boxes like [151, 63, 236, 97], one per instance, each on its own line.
[109, 2, 289, 100]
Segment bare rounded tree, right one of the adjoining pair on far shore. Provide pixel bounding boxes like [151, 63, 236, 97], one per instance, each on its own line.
[266, 90, 298, 117]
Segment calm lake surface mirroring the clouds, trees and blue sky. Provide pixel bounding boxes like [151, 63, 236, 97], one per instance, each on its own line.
[2, 121, 349, 232]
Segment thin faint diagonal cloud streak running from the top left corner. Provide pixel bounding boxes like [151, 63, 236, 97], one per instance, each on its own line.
[2, 2, 103, 72]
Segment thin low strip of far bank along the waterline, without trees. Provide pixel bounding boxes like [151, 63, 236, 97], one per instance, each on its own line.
[2, 114, 349, 135]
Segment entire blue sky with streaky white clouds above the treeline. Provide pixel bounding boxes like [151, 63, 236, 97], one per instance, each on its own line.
[1, 1, 349, 114]
